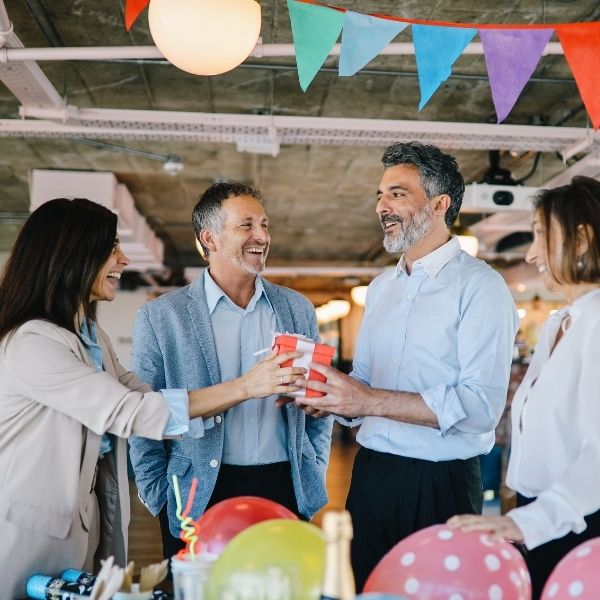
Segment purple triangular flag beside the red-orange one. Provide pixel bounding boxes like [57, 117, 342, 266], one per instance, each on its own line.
[479, 29, 554, 123]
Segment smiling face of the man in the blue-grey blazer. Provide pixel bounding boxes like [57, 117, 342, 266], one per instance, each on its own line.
[209, 196, 271, 275]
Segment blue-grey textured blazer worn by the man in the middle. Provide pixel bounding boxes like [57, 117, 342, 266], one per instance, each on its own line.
[129, 276, 332, 536]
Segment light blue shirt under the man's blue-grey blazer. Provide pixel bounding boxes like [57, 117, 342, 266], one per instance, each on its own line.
[204, 269, 289, 465]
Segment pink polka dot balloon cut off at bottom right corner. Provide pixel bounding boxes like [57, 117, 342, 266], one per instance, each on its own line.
[542, 538, 600, 600]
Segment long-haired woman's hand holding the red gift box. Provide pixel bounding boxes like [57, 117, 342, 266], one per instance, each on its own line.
[240, 352, 306, 398]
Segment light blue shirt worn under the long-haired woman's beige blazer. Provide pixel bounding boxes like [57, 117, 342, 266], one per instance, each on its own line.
[80, 319, 192, 450]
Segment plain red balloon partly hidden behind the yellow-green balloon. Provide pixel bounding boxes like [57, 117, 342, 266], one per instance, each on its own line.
[198, 496, 298, 554]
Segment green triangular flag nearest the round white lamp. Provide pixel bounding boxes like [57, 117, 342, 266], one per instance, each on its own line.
[288, 0, 344, 92]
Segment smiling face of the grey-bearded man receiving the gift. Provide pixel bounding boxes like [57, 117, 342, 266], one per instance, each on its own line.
[376, 165, 433, 253]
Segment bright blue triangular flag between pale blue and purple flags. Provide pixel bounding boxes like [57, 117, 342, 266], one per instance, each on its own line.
[412, 25, 477, 110]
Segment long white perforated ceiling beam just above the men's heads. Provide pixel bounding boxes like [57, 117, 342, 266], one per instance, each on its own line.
[0, 107, 600, 152]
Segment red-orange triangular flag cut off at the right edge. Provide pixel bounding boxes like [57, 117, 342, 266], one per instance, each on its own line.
[556, 22, 600, 129]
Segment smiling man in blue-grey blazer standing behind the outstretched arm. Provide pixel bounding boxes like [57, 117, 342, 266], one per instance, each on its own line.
[130, 183, 332, 557]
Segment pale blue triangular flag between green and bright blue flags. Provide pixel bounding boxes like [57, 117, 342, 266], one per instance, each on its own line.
[339, 11, 408, 77]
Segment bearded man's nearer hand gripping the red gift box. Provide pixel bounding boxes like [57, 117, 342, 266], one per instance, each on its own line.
[295, 363, 371, 418]
